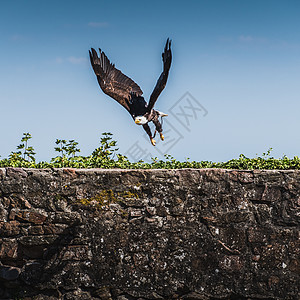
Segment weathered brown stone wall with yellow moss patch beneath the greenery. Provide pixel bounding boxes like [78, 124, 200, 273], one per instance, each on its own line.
[0, 168, 300, 300]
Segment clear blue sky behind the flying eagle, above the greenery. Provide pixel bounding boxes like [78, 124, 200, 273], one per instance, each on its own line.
[0, 0, 300, 161]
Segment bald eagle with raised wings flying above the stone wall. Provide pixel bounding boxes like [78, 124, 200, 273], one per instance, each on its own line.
[89, 39, 172, 146]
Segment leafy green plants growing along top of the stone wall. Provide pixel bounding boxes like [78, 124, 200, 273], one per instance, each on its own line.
[0, 132, 300, 170]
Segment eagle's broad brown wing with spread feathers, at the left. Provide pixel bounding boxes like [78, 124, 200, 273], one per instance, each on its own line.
[89, 48, 143, 111]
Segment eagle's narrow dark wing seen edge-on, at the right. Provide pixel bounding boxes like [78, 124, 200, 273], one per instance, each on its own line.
[148, 38, 172, 111]
